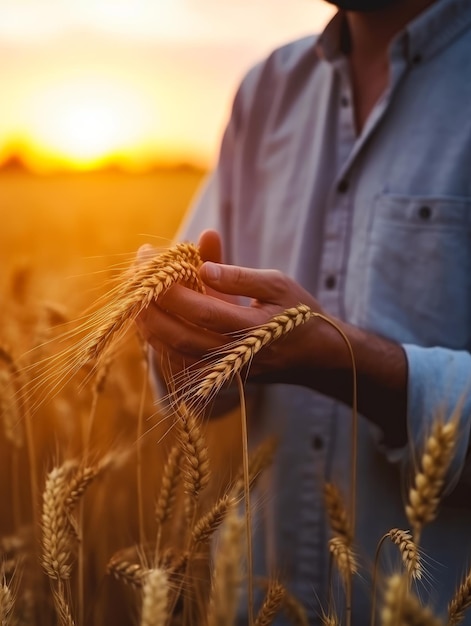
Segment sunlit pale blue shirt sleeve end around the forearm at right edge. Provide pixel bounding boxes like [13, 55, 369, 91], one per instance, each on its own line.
[403, 344, 471, 493]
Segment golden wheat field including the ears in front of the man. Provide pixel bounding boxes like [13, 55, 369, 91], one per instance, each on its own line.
[0, 169, 471, 626]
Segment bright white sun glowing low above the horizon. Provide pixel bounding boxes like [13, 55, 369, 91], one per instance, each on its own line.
[26, 79, 155, 169]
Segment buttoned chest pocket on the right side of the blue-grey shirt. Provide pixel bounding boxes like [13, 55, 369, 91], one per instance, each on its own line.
[361, 195, 471, 349]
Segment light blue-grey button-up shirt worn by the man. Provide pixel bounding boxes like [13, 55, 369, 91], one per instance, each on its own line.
[178, 0, 471, 626]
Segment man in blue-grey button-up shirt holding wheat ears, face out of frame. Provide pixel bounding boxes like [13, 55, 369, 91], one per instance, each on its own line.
[139, 0, 471, 625]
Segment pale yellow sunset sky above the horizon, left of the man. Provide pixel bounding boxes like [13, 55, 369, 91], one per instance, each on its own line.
[0, 0, 338, 169]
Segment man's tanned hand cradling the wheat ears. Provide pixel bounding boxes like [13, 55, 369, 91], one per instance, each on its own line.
[139, 238, 346, 382]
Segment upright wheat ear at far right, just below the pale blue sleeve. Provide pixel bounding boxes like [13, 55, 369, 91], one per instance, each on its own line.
[406, 419, 458, 544]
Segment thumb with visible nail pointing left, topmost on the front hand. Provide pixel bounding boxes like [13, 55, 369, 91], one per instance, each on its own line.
[200, 262, 289, 304]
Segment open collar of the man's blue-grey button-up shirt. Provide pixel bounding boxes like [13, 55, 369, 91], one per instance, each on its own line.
[316, 0, 471, 64]
